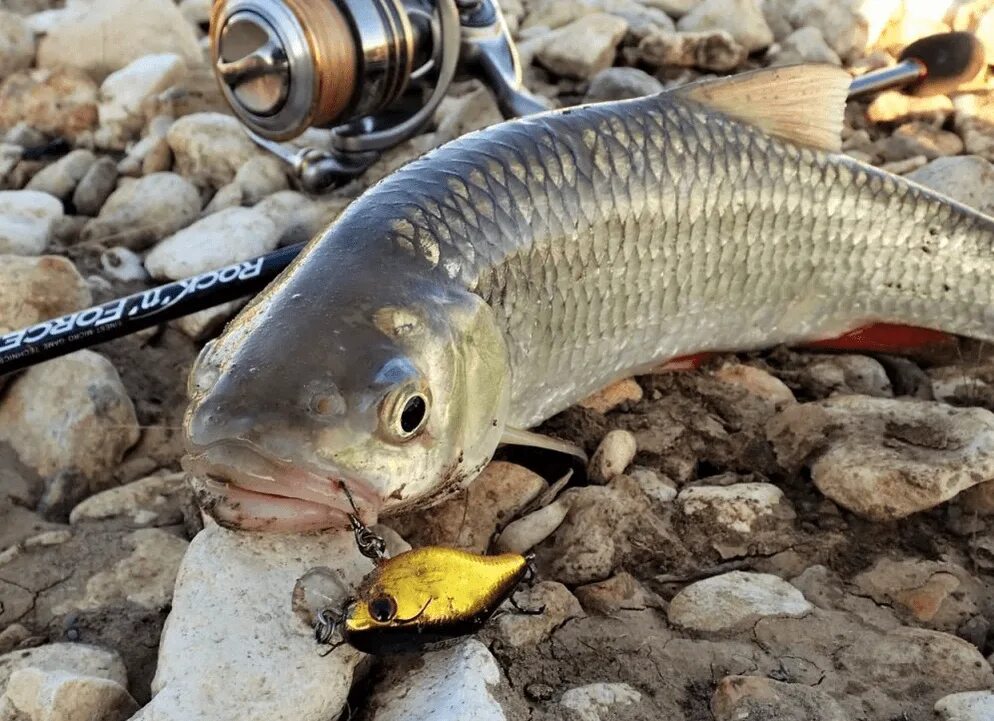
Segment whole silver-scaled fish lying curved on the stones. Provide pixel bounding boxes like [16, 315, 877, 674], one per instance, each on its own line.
[184, 65, 994, 531]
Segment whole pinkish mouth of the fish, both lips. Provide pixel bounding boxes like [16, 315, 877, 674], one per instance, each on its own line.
[182, 441, 382, 532]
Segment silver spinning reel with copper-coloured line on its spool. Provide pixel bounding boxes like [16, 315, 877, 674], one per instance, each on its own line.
[210, 0, 548, 192]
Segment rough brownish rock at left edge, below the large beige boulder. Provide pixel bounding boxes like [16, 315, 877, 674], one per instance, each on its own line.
[0, 68, 97, 142]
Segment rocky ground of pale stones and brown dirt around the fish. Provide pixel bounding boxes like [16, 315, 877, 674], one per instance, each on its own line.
[0, 0, 994, 721]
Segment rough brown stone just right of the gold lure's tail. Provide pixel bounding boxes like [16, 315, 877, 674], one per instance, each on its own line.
[496, 581, 586, 648]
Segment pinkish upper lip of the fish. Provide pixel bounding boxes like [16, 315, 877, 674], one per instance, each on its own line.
[181, 440, 383, 519]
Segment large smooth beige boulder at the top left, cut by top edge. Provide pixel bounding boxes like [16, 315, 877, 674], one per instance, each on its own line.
[38, 0, 203, 79]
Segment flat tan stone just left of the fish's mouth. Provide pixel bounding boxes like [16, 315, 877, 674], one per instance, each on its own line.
[69, 473, 188, 528]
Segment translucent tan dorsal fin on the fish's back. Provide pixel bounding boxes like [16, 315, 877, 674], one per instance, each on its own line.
[673, 65, 852, 153]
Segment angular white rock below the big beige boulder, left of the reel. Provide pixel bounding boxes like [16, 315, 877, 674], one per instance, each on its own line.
[96, 53, 187, 150]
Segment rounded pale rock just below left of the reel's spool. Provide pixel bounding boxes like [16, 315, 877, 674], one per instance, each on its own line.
[166, 112, 263, 189]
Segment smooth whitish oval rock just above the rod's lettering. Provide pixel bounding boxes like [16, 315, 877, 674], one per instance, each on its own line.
[145, 208, 280, 280]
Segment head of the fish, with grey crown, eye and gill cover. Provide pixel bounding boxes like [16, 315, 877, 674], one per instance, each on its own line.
[184, 253, 509, 531]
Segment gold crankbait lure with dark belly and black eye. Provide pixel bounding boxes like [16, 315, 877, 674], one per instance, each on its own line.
[314, 484, 542, 654]
